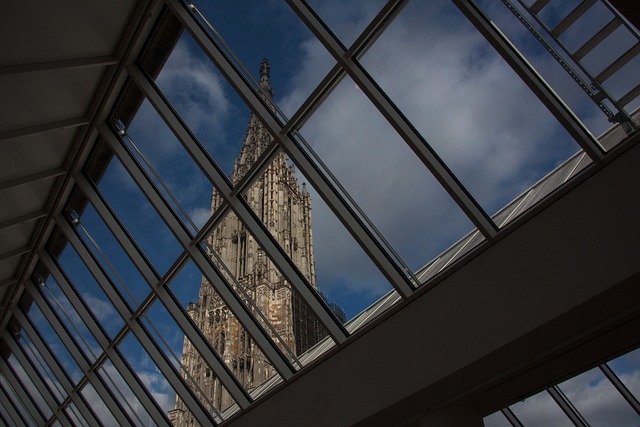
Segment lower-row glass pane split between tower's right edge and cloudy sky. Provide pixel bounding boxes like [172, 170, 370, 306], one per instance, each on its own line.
[240, 145, 400, 324]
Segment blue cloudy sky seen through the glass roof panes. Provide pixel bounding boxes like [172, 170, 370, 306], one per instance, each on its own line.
[13, 0, 640, 425]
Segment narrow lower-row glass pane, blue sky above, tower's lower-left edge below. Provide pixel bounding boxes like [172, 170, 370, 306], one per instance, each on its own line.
[142, 301, 228, 421]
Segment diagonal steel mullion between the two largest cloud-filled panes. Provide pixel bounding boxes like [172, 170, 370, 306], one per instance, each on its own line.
[287, 0, 498, 240]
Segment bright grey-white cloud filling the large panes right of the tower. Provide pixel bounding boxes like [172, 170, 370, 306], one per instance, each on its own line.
[283, 2, 578, 304]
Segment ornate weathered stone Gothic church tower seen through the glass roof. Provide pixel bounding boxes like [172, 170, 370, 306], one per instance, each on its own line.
[169, 59, 324, 426]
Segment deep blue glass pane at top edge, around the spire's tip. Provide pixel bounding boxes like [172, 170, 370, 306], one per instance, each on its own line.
[181, 0, 335, 118]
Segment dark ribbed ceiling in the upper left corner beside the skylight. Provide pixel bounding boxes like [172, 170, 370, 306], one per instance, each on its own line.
[0, 0, 148, 327]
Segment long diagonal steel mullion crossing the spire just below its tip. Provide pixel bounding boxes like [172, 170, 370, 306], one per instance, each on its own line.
[166, 0, 413, 298]
